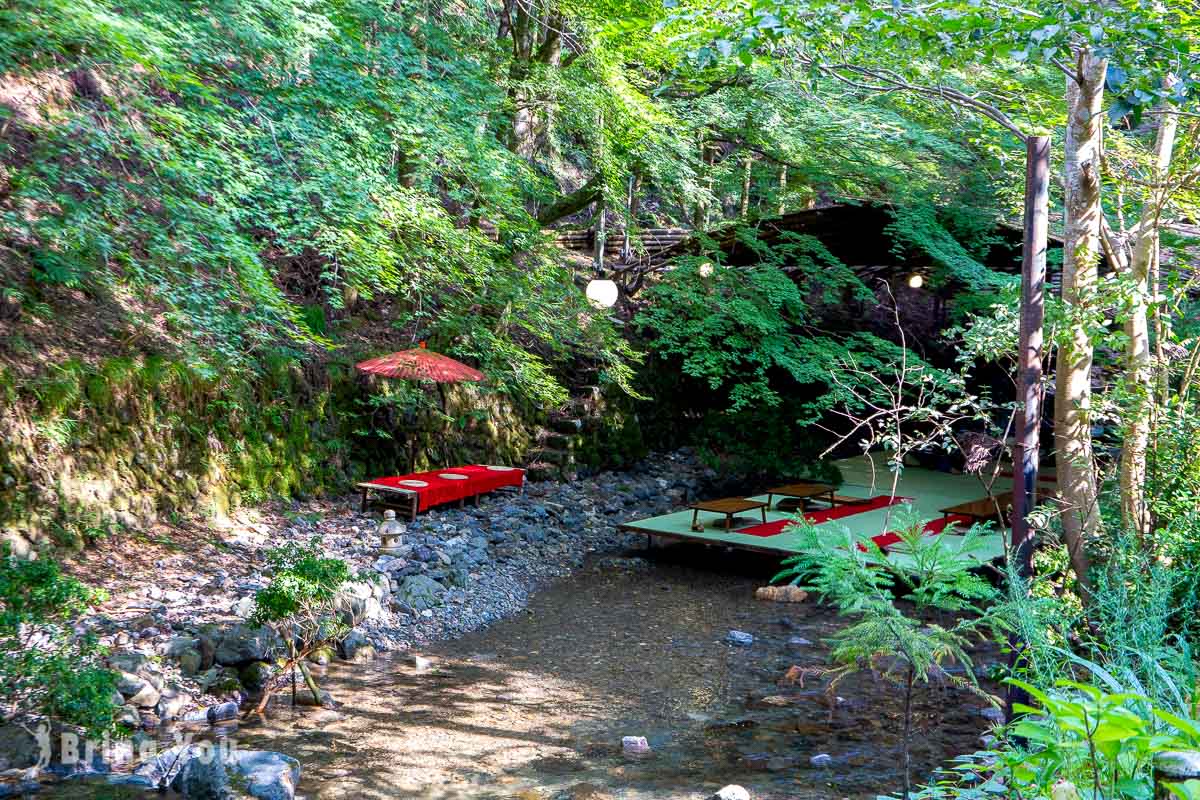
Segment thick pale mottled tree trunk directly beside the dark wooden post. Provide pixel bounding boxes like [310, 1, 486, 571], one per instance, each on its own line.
[1055, 48, 1106, 597]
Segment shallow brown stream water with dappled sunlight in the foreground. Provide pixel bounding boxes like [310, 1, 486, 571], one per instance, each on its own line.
[35, 547, 995, 800]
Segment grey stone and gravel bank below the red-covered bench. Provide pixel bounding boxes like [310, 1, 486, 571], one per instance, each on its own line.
[0, 451, 715, 796]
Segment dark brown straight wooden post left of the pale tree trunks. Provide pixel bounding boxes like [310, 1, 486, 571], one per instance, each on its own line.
[1004, 136, 1050, 720]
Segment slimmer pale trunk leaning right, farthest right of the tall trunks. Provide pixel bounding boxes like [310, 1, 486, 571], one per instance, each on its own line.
[1121, 79, 1178, 546]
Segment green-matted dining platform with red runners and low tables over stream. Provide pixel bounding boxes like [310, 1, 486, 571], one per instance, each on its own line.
[620, 456, 1004, 563]
